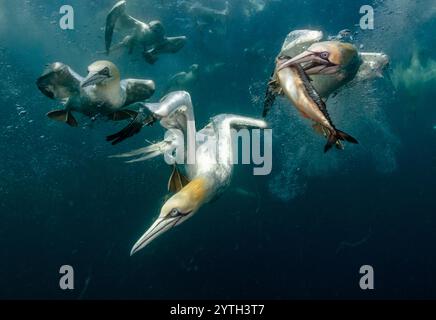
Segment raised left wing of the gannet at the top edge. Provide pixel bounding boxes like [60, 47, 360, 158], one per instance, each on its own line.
[105, 1, 143, 52]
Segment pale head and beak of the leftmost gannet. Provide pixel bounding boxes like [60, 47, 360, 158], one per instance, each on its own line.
[81, 60, 120, 88]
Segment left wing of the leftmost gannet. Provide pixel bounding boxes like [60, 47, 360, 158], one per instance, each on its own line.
[36, 62, 83, 100]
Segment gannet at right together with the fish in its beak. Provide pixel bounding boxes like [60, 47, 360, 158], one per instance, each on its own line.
[263, 30, 389, 151]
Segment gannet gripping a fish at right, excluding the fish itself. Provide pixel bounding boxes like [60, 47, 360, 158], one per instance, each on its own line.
[264, 30, 389, 108]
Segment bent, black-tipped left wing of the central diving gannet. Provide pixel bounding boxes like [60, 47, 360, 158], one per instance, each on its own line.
[106, 91, 195, 145]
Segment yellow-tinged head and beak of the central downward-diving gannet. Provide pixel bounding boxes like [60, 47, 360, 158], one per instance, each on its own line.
[130, 178, 207, 255]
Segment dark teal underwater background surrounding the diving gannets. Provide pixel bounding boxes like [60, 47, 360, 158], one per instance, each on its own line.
[0, 0, 436, 299]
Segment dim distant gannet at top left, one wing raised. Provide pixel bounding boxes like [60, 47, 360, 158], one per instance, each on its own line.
[105, 1, 186, 64]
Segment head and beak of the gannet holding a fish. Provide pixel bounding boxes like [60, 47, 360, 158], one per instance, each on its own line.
[277, 41, 358, 74]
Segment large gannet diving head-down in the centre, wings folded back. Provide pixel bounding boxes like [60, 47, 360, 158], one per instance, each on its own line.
[110, 91, 267, 255]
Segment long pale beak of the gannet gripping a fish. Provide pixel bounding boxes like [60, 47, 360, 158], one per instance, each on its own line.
[277, 50, 339, 75]
